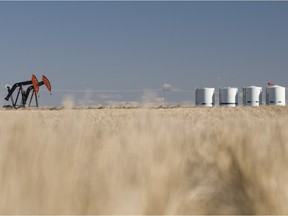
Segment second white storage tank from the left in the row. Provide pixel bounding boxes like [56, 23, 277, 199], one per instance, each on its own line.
[219, 87, 238, 107]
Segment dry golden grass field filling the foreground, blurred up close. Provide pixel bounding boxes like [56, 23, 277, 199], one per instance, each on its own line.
[0, 106, 288, 215]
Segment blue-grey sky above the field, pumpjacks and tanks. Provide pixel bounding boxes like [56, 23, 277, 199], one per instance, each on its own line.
[0, 1, 288, 104]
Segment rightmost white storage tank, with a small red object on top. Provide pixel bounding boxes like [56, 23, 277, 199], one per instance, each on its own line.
[266, 85, 286, 106]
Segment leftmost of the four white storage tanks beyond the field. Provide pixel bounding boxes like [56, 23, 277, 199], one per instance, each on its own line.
[195, 88, 215, 107]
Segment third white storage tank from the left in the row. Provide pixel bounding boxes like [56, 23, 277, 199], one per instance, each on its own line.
[243, 86, 262, 106]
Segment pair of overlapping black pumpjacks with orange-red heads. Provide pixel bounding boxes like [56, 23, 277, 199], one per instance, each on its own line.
[5, 74, 51, 109]
